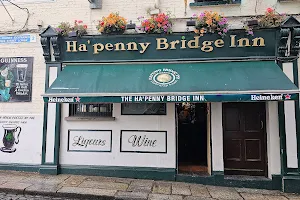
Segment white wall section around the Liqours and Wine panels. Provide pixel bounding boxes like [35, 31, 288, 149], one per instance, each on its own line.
[60, 103, 176, 168]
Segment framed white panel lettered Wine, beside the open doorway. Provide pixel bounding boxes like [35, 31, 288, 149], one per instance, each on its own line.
[121, 130, 167, 153]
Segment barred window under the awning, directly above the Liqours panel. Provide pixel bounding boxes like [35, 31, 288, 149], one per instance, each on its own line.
[69, 103, 113, 117]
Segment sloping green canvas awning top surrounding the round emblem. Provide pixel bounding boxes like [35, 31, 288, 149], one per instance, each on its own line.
[46, 61, 297, 97]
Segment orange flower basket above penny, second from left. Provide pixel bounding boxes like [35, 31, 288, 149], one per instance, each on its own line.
[97, 13, 127, 35]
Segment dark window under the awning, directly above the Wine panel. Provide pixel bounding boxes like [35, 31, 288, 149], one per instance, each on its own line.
[121, 103, 167, 115]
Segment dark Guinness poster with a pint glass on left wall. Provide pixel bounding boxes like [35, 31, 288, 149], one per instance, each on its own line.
[0, 57, 33, 102]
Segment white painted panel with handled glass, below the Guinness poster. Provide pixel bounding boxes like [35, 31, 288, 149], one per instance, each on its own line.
[0, 115, 43, 164]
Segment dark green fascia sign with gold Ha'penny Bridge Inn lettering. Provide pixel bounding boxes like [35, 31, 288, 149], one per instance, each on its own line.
[62, 29, 277, 62]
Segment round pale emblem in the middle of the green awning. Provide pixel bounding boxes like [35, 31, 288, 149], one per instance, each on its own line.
[149, 68, 180, 87]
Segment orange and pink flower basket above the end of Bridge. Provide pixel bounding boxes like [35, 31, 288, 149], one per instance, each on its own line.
[194, 11, 228, 37]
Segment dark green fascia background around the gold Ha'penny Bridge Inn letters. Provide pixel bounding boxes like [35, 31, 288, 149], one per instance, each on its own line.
[61, 29, 279, 63]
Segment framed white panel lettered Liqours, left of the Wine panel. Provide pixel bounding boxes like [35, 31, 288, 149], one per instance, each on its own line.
[68, 130, 112, 152]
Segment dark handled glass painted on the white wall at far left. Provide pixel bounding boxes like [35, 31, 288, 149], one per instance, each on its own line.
[0, 124, 21, 153]
